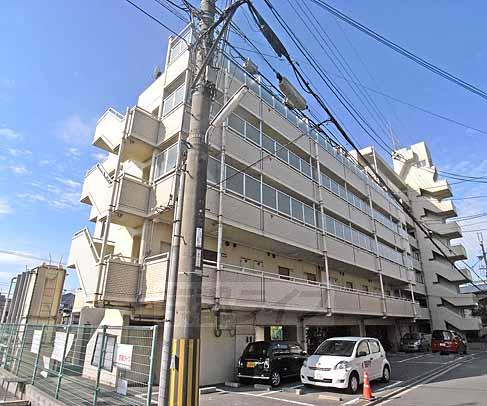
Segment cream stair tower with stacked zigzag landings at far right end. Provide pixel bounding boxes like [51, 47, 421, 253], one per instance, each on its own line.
[394, 142, 480, 335]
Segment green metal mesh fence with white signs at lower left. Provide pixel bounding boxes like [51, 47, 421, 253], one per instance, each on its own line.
[0, 324, 157, 405]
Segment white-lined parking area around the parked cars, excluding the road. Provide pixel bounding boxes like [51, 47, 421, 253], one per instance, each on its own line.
[200, 353, 469, 406]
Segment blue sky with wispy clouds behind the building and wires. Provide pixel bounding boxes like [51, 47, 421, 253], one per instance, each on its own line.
[0, 0, 487, 291]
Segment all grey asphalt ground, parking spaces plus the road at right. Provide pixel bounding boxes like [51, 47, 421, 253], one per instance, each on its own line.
[200, 352, 487, 406]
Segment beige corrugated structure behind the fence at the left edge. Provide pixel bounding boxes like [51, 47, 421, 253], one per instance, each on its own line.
[4, 264, 66, 324]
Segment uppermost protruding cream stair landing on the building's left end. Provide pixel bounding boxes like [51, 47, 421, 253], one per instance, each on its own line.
[93, 106, 160, 162]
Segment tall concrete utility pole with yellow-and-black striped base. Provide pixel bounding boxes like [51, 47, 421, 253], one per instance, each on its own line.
[169, 0, 216, 406]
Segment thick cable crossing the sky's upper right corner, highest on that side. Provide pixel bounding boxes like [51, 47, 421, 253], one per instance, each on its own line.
[310, 0, 487, 100]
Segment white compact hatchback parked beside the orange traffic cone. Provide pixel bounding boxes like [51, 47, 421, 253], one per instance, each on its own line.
[301, 337, 391, 393]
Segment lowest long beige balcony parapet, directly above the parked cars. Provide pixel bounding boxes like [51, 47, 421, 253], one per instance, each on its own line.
[202, 264, 414, 318]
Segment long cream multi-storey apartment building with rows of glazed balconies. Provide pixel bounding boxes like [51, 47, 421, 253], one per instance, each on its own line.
[69, 30, 480, 384]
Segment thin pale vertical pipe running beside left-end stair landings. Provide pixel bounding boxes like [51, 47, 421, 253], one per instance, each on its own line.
[93, 107, 131, 307]
